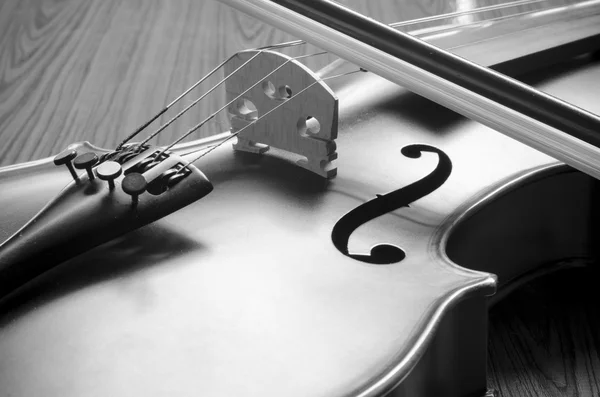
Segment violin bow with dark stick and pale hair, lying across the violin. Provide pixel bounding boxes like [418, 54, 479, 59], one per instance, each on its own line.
[220, 0, 600, 179]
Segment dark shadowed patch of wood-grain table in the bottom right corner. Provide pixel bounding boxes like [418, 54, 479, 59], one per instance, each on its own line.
[488, 267, 600, 397]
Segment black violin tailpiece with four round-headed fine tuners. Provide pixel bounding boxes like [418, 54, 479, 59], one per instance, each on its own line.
[0, 145, 213, 298]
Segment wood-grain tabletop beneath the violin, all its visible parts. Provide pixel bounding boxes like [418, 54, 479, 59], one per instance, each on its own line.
[0, 0, 600, 396]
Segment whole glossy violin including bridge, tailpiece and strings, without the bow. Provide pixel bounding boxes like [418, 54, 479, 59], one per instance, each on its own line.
[0, 0, 600, 396]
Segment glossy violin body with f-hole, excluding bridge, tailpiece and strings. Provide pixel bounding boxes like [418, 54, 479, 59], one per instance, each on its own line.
[0, 53, 600, 396]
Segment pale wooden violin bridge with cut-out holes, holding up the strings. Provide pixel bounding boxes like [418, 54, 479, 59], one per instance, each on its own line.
[225, 50, 338, 178]
